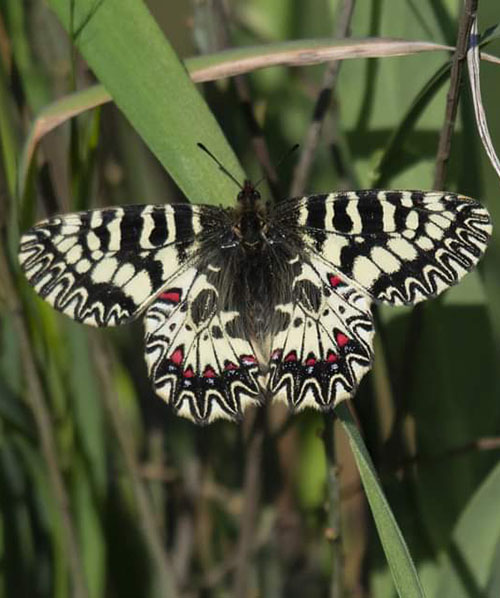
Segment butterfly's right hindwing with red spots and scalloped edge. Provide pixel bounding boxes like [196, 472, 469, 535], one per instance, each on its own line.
[268, 260, 374, 410]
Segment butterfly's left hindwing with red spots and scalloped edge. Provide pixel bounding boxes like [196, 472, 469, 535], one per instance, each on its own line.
[145, 266, 262, 424]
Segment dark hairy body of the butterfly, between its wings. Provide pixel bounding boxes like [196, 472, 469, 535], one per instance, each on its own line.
[195, 181, 301, 342]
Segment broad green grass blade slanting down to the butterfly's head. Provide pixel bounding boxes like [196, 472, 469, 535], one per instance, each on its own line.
[48, 0, 244, 204]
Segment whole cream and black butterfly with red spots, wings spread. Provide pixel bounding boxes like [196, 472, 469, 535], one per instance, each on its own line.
[19, 175, 492, 424]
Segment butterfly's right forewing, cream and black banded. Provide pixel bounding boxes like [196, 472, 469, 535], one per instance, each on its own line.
[276, 190, 491, 305]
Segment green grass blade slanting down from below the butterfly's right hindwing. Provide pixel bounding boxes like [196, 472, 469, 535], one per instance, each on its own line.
[335, 402, 425, 598]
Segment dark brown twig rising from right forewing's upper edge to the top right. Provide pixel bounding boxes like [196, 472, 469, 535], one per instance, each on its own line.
[434, 0, 478, 189]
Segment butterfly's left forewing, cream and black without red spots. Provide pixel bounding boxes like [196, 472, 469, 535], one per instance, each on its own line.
[19, 204, 222, 326]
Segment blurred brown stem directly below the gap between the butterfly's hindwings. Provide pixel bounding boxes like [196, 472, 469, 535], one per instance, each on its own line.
[233, 407, 266, 598]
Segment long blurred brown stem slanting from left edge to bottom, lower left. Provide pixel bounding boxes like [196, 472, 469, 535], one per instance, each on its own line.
[0, 251, 89, 598]
